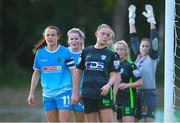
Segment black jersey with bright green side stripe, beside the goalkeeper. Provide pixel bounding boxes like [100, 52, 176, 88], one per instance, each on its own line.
[116, 60, 141, 108]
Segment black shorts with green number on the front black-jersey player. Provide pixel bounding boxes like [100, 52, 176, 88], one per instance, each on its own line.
[82, 97, 112, 113]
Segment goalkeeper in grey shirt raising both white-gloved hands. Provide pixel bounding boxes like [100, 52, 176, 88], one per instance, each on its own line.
[128, 5, 159, 122]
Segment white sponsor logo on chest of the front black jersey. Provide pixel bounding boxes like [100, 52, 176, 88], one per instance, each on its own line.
[85, 61, 104, 71]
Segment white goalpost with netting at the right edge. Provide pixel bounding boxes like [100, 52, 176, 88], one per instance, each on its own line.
[164, 0, 180, 122]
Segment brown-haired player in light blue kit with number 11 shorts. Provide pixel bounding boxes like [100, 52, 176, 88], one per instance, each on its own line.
[28, 26, 79, 122]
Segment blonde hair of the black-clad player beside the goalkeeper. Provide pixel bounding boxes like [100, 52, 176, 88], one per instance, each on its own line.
[113, 40, 131, 59]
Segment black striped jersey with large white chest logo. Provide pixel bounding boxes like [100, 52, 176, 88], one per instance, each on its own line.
[77, 46, 120, 98]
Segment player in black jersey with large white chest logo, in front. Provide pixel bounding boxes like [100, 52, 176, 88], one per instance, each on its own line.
[77, 24, 120, 122]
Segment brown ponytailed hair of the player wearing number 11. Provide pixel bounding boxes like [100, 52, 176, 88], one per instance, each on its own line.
[32, 26, 60, 54]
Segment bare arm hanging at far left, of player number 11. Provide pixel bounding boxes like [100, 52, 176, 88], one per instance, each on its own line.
[28, 70, 40, 105]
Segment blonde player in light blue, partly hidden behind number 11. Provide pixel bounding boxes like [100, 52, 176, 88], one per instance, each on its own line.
[67, 28, 85, 122]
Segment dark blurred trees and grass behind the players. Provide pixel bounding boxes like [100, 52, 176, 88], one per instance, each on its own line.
[0, 0, 165, 122]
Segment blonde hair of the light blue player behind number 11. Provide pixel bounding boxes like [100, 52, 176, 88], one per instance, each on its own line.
[67, 28, 85, 49]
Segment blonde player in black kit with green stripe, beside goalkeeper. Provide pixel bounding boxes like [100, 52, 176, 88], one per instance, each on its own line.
[114, 40, 142, 122]
